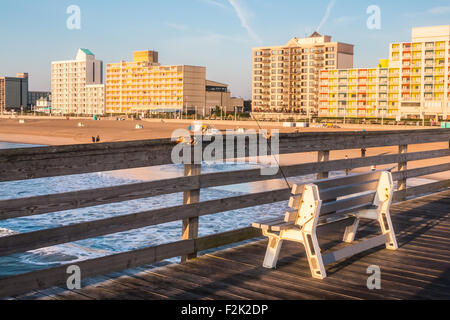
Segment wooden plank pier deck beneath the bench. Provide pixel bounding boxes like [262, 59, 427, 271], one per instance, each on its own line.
[21, 190, 450, 300]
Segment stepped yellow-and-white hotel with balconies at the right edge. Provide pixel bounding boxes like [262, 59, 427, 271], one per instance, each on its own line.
[319, 26, 450, 119]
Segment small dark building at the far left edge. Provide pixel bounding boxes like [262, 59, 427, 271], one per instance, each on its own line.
[0, 73, 28, 113]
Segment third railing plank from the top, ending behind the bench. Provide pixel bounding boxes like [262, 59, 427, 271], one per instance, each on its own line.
[0, 189, 290, 256]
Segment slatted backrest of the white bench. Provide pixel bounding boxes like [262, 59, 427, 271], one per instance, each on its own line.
[285, 171, 393, 224]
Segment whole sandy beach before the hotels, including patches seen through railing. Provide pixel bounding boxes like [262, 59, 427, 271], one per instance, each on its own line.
[0, 118, 450, 180]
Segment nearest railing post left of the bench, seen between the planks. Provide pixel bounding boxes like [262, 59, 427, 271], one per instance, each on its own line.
[181, 164, 202, 263]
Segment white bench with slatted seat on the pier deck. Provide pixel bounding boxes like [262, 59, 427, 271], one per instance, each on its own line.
[253, 171, 398, 279]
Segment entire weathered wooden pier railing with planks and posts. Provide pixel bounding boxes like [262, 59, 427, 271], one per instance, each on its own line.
[0, 129, 450, 297]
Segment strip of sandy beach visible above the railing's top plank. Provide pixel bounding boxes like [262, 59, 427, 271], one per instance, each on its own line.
[0, 117, 432, 145]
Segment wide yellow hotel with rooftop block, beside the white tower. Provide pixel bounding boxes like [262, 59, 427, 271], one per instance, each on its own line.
[106, 51, 206, 114]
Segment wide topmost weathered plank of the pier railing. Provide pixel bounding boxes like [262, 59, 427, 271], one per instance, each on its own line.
[0, 129, 450, 181]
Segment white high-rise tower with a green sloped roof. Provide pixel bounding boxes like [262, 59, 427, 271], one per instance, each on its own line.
[52, 49, 105, 115]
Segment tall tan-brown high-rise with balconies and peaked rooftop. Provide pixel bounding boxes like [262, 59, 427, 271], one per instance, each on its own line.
[252, 32, 353, 113]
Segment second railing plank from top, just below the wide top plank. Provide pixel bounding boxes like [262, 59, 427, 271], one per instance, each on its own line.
[0, 149, 450, 220]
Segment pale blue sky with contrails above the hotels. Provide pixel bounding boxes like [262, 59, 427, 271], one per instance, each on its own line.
[0, 0, 450, 98]
